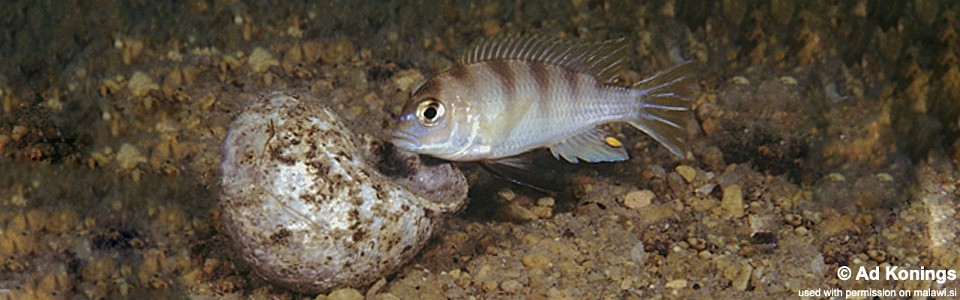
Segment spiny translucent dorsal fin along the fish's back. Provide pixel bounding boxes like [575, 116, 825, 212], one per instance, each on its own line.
[460, 36, 627, 82]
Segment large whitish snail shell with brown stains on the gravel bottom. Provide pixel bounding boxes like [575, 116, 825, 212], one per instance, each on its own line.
[221, 92, 467, 292]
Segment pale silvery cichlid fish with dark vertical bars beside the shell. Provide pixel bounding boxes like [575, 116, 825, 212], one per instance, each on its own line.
[392, 37, 697, 163]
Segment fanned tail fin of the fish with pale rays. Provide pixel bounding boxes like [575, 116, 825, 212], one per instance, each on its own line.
[628, 62, 697, 157]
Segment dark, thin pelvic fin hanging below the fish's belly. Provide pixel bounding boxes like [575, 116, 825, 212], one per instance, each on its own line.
[480, 156, 560, 194]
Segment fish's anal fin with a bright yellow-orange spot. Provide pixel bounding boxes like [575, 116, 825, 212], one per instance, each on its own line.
[550, 127, 630, 163]
